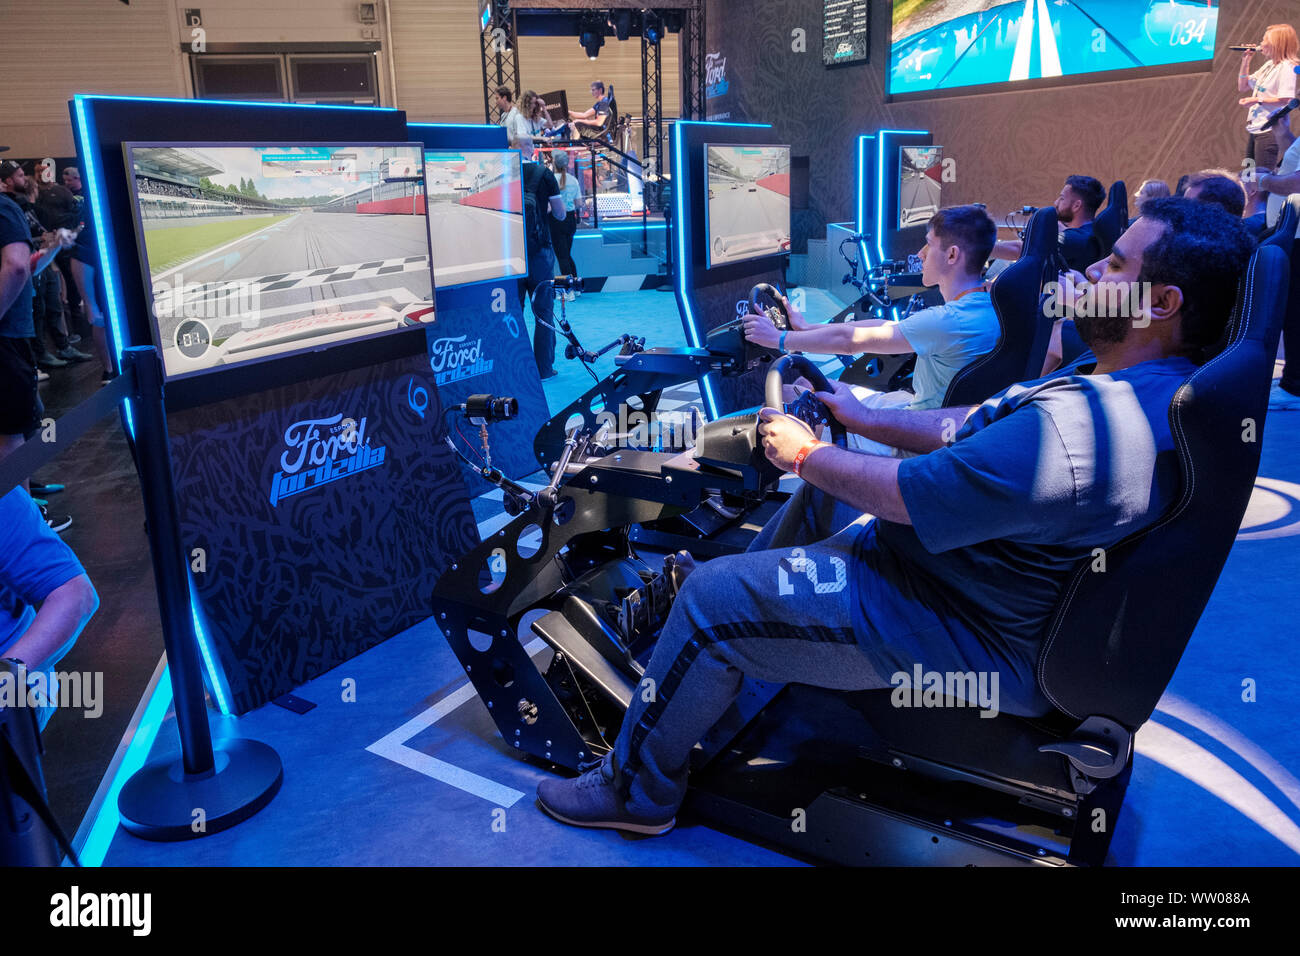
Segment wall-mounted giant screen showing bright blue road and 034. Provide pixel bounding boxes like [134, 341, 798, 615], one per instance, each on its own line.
[889, 0, 1218, 94]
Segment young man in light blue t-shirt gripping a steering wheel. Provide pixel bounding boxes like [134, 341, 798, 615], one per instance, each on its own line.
[745, 206, 1001, 454]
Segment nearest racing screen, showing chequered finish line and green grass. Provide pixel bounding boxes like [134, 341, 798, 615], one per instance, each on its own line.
[125, 143, 433, 377]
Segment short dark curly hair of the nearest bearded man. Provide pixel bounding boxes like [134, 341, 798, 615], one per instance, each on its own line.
[1138, 196, 1255, 362]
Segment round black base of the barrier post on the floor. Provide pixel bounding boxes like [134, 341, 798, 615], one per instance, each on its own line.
[117, 740, 285, 842]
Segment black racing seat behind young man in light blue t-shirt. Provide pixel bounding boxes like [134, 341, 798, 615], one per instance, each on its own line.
[944, 207, 1058, 408]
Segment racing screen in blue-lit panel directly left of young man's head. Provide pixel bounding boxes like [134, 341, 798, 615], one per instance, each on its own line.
[705, 146, 790, 268]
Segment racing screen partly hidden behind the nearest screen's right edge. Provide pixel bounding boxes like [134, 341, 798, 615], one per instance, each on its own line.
[424, 150, 528, 286]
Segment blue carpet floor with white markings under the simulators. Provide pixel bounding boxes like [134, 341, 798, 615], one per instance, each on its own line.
[92, 290, 1300, 866]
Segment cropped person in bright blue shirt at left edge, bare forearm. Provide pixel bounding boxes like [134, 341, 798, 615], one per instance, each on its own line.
[0, 488, 99, 728]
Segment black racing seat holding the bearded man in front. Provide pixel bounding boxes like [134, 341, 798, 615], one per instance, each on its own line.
[848, 246, 1290, 864]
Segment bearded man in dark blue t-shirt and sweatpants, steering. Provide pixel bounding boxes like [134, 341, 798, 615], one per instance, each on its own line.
[537, 199, 1255, 834]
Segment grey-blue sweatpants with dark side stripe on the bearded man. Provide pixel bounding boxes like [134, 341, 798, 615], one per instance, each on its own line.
[614, 485, 891, 818]
